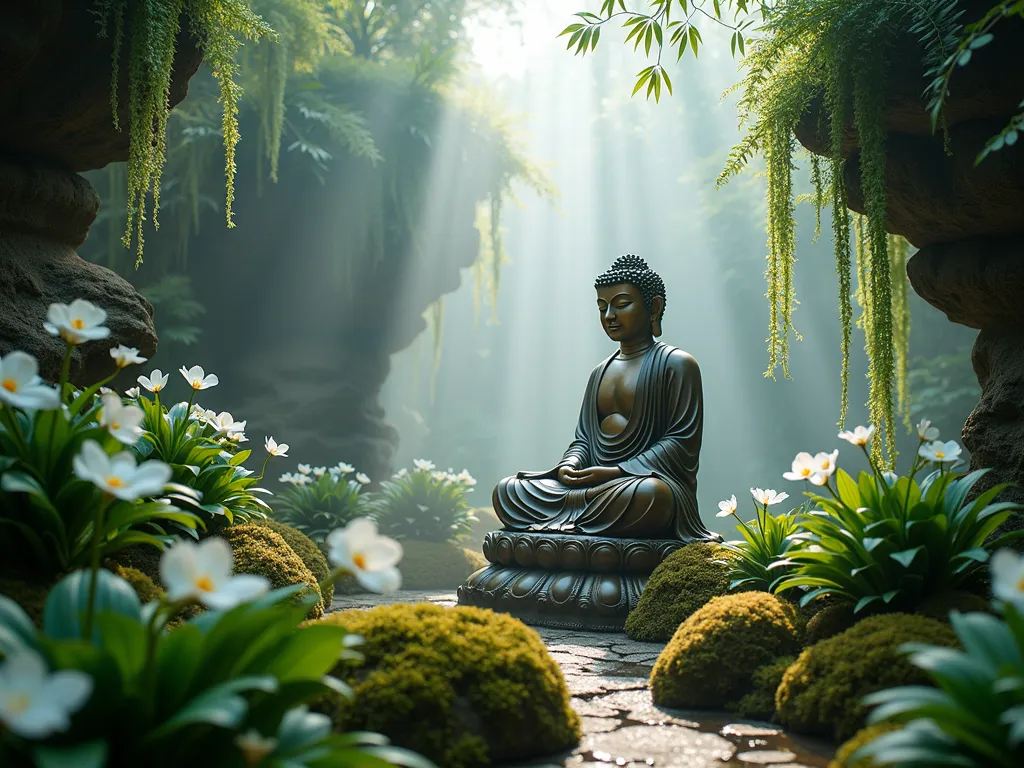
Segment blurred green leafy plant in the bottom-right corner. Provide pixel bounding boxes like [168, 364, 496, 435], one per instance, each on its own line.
[857, 569, 1024, 768]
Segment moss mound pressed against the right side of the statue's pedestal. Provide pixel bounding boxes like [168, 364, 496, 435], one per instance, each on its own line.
[626, 543, 730, 642]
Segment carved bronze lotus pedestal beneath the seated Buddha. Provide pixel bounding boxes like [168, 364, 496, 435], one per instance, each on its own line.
[459, 530, 683, 632]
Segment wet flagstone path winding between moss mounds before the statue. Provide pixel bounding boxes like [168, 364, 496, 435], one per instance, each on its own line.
[332, 591, 834, 768]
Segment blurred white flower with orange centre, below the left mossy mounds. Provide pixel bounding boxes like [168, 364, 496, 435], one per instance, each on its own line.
[160, 537, 270, 610]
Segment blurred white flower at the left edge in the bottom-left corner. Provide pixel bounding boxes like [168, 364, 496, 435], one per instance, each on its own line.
[0, 648, 93, 739]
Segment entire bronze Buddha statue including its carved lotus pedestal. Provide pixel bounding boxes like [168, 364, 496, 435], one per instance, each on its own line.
[459, 255, 721, 631]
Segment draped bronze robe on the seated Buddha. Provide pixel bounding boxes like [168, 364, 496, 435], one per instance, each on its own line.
[494, 343, 721, 542]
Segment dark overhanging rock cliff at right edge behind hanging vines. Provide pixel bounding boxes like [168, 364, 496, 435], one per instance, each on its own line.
[797, 0, 1024, 527]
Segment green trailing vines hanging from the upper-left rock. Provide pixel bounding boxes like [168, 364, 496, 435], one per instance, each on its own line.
[93, 0, 273, 266]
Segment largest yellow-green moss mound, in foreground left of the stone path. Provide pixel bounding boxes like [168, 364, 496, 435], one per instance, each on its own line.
[323, 604, 580, 768]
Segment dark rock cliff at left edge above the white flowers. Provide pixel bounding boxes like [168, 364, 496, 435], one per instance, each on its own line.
[0, 0, 202, 383]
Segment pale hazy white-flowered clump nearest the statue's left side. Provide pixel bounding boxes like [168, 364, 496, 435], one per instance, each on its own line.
[367, 462, 476, 542]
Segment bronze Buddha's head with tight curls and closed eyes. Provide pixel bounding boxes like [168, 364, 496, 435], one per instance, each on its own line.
[594, 254, 665, 342]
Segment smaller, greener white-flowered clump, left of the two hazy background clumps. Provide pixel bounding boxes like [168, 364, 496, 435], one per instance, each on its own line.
[272, 464, 368, 544]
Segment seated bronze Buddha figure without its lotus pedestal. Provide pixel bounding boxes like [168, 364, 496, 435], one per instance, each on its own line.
[493, 255, 721, 542]
